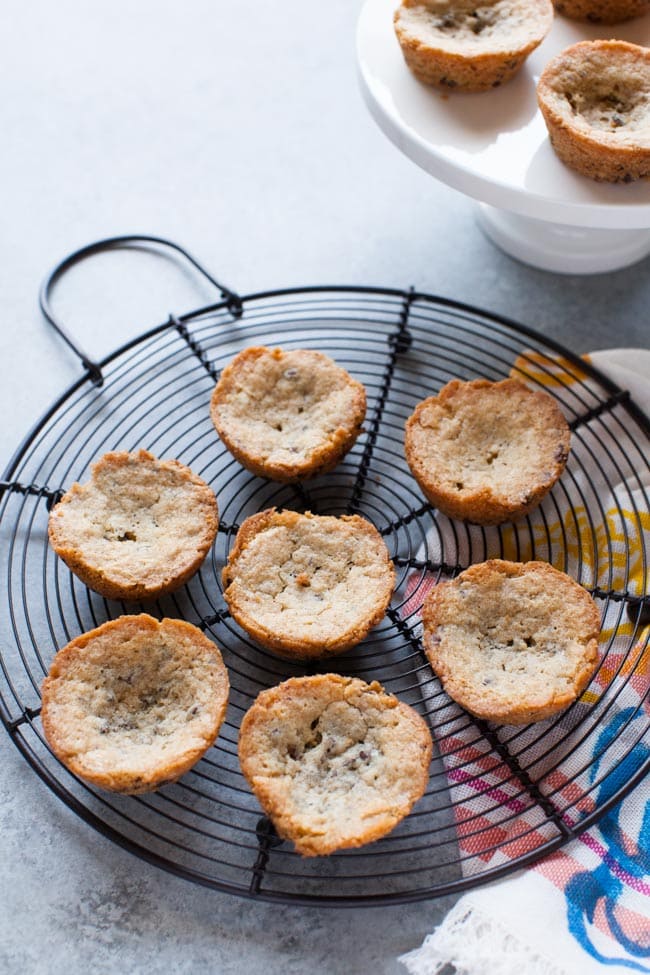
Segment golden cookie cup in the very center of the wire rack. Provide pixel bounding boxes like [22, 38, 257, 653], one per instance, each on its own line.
[223, 508, 395, 659]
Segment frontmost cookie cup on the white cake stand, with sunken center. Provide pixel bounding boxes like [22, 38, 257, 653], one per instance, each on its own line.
[537, 41, 650, 183]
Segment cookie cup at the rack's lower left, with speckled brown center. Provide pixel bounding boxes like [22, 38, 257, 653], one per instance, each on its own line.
[41, 613, 229, 795]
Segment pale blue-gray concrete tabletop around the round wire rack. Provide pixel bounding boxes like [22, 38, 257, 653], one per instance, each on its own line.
[0, 0, 650, 975]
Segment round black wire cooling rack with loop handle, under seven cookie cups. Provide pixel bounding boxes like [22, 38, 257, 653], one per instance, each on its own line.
[0, 237, 650, 906]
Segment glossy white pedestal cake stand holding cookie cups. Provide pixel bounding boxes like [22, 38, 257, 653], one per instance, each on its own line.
[357, 0, 650, 274]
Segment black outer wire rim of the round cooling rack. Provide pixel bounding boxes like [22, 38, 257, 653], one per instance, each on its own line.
[0, 284, 650, 907]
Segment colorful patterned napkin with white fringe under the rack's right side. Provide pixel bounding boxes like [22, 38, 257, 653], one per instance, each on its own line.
[400, 349, 650, 975]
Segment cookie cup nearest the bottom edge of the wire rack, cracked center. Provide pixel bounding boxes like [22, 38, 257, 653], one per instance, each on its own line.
[239, 674, 432, 857]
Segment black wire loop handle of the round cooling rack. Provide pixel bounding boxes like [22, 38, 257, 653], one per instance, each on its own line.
[38, 234, 243, 386]
